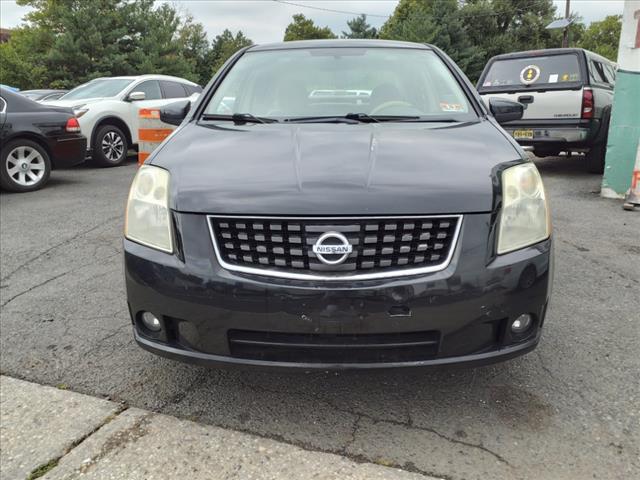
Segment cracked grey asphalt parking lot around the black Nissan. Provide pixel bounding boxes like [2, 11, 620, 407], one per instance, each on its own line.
[0, 157, 640, 480]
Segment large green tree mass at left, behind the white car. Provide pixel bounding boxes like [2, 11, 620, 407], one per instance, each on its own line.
[0, 0, 208, 88]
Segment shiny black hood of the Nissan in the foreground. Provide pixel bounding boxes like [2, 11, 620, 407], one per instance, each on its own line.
[151, 120, 521, 215]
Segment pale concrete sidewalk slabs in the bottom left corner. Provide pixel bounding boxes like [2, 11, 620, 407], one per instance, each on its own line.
[0, 376, 434, 480]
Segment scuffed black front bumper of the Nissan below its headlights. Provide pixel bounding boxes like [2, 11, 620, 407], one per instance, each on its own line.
[124, 214, 553, 370]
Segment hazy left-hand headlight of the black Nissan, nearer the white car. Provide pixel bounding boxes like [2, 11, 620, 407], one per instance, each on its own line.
[124, 165, 173, 253]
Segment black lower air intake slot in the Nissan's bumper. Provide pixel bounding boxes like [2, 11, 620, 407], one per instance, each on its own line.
[228, 330, 440, 363]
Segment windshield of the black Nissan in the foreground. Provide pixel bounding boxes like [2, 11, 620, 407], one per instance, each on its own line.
[204, 47, 476, 121]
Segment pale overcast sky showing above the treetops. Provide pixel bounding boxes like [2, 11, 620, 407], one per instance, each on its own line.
[0, 0, 624, 43]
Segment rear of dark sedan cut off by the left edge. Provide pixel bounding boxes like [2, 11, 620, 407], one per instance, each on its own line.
[0, 87, 87, 193]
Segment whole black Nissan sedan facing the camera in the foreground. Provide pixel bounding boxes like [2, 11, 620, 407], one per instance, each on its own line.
[124, 40, 553, 370]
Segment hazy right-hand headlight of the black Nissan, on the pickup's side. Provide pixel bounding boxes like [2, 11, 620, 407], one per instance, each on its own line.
[498, 163, 551, 254]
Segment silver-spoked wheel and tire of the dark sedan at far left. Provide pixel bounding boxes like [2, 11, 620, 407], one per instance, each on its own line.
[0, 138, 51, 193]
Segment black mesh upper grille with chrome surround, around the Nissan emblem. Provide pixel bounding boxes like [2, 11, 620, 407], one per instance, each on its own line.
[209, 215, 462, 279]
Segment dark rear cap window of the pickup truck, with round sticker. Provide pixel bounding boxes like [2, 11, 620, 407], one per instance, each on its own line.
[480, 53, 582, 88]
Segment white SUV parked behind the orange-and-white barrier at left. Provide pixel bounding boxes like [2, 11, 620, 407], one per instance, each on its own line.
[43, 75, 202, 167]
